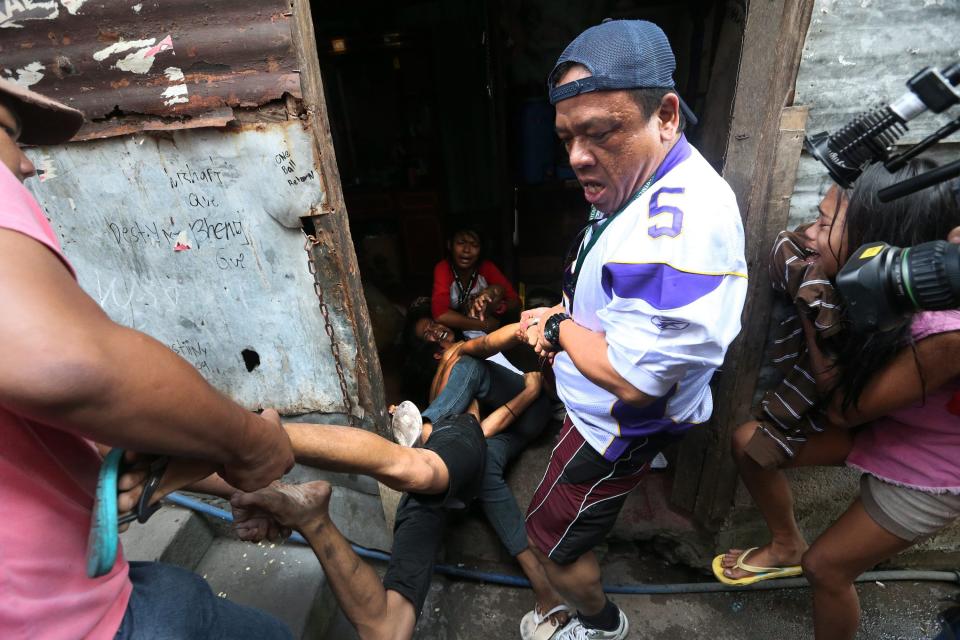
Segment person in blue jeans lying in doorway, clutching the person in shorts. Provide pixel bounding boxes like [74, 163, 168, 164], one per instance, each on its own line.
[396, 307, 569, 637]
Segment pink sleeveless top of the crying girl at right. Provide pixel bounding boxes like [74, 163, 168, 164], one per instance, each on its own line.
[847, 310, 960, 494]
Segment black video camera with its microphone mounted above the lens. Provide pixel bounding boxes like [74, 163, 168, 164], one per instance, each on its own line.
[804, 62, 960, 331]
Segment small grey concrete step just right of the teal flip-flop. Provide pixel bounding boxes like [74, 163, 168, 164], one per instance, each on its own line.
[120, 504, 214, 569]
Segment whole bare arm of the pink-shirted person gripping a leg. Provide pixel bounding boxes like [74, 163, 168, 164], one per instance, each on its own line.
[0, 229, 293, 488]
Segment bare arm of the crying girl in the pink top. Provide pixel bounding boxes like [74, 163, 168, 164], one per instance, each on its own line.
[827, 332, 960, 428]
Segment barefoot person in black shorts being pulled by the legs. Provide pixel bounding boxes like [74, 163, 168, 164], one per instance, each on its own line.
[118, 387, 536, 639]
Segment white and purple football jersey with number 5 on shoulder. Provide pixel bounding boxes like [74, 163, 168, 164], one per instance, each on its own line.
[554, 136, 747, 460]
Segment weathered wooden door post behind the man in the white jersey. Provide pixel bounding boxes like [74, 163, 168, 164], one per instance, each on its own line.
[671, 0, 814, 530]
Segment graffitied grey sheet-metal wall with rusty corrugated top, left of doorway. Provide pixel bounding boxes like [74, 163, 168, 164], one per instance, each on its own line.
[0, 5, 382, 423]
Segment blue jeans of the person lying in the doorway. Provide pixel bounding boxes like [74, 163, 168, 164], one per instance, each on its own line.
[423, 356, 550, 556]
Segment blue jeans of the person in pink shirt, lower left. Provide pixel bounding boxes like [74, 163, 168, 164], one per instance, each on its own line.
[116, 562, 293, 640]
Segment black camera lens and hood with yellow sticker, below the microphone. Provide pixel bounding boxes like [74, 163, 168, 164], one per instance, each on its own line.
[837, 240, 960, 331]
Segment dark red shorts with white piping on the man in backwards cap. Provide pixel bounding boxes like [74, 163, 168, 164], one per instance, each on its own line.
[527, 418, 682, 564]
